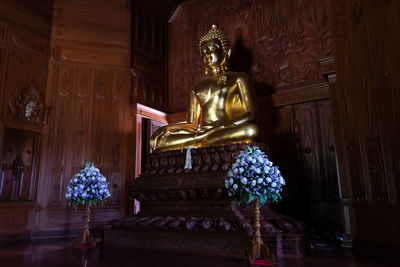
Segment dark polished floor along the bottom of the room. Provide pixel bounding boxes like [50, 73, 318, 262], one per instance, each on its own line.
[0, 239, 400, 267]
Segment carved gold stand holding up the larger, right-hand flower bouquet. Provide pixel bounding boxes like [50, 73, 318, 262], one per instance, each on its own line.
[248, 198, 276, 266]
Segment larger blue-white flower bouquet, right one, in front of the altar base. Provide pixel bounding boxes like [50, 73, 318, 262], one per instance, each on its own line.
[225, 146, 285, 205]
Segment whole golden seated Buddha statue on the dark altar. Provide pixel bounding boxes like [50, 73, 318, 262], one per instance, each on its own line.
[150, 25, 258, 151]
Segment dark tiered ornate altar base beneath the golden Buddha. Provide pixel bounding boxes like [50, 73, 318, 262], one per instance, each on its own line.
[104, 143, 304, 257]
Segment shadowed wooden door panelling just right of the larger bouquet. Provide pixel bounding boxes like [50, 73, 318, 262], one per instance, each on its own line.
[276, 99, 342, 233]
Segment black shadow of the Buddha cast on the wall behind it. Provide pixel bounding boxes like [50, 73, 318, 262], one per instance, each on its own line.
[228, 28, 306, 221]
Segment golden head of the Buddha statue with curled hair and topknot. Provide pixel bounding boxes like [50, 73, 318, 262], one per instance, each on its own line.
[199, 24, 231, 75]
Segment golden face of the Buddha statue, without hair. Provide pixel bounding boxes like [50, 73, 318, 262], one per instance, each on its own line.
[201, 39, 225, 72]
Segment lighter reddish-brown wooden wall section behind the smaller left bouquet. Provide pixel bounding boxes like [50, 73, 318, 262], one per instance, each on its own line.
[32, 0, 133, 235]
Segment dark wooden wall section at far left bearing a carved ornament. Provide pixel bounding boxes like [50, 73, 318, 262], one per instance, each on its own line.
[0, 0, 52, 240]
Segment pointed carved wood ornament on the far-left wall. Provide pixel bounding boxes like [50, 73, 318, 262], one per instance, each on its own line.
[8, 80, 48, 126]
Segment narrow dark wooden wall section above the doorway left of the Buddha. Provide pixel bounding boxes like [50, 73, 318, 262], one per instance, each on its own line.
[131, 1, 167, 111]
